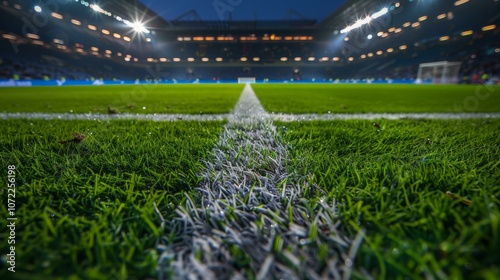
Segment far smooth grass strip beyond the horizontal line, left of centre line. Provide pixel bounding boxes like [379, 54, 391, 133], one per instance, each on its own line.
[0, 84, 243, 114]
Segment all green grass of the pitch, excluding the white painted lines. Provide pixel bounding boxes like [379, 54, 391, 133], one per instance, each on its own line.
[0, 82, 500, 279]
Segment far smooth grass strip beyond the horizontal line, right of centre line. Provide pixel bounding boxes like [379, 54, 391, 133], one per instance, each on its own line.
[252, 84, 500, 114]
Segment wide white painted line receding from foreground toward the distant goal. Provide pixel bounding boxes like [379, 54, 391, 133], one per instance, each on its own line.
[158, 85, 358, 279]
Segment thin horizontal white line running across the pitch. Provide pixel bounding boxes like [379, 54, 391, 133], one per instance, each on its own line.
[0, 112, 500, 122]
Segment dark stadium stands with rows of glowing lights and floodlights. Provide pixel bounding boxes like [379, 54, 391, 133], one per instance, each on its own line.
[0, 0, 500, 85]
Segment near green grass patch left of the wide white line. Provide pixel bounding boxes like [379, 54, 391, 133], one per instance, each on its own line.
[0, 120, 223, 279]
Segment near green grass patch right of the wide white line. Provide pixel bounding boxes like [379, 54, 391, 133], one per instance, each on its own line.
[279, 120, 500, 279]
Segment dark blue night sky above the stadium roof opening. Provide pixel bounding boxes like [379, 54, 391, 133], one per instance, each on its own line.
[140, 0, 346, 21]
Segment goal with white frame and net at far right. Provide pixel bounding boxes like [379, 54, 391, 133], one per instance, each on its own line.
[416, 61, 462, 84]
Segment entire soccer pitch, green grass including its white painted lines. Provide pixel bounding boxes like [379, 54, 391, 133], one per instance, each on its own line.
[0, 84, 500, 279]
